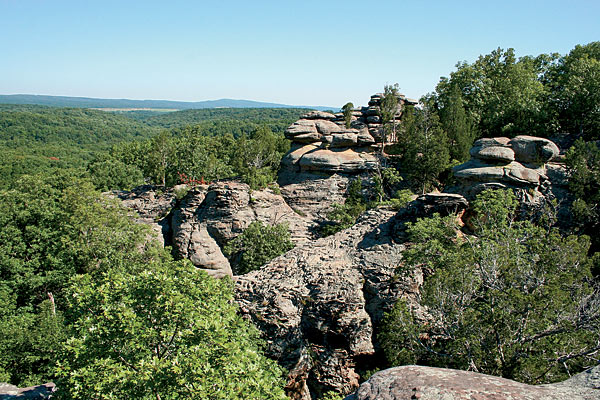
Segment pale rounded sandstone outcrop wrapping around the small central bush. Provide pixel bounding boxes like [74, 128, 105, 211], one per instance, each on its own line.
[114, 180, 314, 277]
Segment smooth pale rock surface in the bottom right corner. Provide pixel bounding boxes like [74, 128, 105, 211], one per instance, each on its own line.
[345, 365, 600, 400]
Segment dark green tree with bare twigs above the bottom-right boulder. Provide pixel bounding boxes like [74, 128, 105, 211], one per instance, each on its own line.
[381, 191, 600, 383]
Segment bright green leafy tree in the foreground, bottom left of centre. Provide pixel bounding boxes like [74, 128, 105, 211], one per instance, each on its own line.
[56, 258, 286, 400]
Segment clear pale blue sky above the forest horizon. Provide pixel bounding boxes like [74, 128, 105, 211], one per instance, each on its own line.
[0, 0, 600, 107]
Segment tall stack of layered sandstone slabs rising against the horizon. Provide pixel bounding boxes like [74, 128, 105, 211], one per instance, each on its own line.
[282, 94, 416, 174]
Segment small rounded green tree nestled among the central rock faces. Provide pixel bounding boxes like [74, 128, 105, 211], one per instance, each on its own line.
[224, 221, 294, 274]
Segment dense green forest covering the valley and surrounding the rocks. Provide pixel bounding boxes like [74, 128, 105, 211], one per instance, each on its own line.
[0, 42, 600, 399]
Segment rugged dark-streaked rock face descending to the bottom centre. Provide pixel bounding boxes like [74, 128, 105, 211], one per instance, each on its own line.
[235, 210, 422, 400]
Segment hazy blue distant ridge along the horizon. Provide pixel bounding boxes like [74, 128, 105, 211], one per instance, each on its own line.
[0, 94, 338, 111]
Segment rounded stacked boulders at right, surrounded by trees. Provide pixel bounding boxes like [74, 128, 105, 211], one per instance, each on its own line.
[454, 136, 559, 202]
